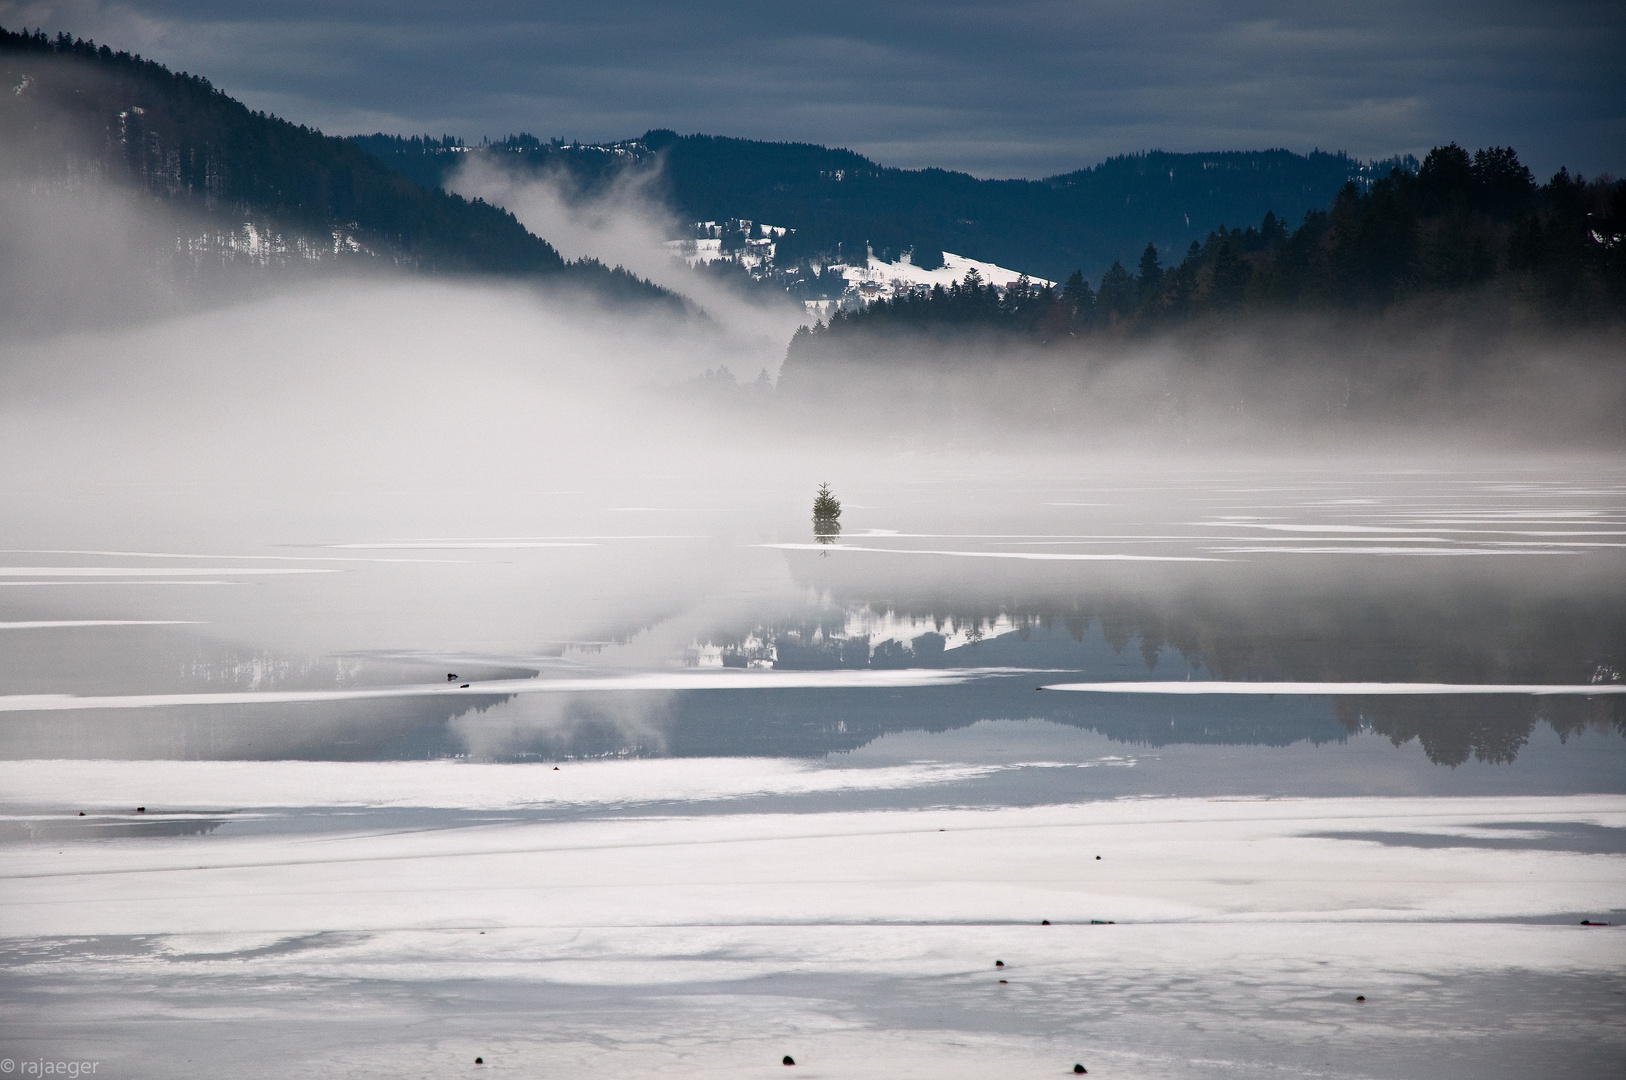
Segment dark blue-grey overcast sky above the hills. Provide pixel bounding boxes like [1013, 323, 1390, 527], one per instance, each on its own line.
[0, 0, 1626, 179]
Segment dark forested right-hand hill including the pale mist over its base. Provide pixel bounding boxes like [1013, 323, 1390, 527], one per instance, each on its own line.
[773, 145, 1626, 452]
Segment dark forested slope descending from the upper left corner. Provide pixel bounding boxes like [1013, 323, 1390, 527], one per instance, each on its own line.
[0, 28, 681, 304]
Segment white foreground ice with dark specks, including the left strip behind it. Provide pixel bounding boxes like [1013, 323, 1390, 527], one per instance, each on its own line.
[0, 761, 1626, 1080]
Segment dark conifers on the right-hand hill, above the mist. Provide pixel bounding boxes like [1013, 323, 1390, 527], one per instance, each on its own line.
[790, 143, 1626, 359]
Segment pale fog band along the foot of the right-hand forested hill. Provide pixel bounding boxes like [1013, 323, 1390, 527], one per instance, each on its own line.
[779, 306, 1626, 457]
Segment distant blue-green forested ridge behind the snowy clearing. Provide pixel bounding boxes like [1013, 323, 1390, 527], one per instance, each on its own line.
[354, 130, 1416, 280]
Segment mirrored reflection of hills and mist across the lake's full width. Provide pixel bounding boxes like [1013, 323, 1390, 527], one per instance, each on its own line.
[0, 548, 1626, 767]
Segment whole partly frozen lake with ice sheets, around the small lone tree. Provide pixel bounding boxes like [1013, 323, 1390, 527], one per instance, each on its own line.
[0, 451, 1626, 1078]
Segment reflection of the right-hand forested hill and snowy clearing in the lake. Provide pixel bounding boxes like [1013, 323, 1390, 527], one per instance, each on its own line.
[695, 560, 1626, 764]
